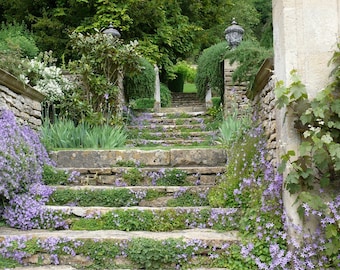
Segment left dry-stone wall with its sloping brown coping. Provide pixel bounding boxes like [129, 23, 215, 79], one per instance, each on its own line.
[0, 69, 44, 129]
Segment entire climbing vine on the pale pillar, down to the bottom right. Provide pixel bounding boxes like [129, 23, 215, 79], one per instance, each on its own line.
[275, 44, 340, 265]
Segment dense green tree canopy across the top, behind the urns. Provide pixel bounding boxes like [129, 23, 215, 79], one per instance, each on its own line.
[0, 0, 271, 74]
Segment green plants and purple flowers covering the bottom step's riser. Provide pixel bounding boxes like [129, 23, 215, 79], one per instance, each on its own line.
[0, 237, 238, 270]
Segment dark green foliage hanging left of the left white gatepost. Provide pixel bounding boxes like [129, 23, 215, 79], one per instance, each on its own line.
[124, 58, 156, 100]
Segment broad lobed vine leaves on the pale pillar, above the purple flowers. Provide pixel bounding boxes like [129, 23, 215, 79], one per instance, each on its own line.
[275, 68, 340, 193]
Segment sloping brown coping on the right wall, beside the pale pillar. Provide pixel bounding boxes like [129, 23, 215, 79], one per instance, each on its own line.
[246, 58, 274, 99]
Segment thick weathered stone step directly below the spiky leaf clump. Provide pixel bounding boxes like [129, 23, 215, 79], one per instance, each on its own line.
[50, 147, 227, 168]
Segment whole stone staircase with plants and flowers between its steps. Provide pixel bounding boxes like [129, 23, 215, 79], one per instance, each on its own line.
[0, 92, 240, 269]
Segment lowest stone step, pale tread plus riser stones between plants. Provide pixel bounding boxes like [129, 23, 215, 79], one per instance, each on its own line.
[0, 228, 241, 270]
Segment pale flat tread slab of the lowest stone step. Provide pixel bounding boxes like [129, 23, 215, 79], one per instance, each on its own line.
[0, 227, 240, 247]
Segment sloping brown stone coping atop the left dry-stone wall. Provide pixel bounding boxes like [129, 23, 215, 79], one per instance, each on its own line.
[0, 68, 45, 102]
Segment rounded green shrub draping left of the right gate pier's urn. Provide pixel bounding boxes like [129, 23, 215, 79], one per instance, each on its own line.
[195, 42, 228, 99]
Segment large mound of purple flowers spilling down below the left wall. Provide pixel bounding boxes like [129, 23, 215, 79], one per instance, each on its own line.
[0, 109, 66, 230]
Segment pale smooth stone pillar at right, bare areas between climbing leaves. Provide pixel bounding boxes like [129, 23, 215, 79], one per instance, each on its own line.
[272, 0, 340, 240]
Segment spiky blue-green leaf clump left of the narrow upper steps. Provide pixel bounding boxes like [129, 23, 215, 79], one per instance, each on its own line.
[41, 119, 127, 149]
